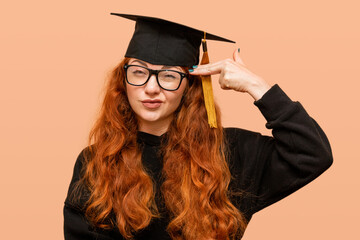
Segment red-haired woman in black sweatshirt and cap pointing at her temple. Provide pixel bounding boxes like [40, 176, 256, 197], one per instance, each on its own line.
[64, 14, 332, 240]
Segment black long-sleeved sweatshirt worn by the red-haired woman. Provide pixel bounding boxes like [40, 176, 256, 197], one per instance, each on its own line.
[64, 85, 333, 240]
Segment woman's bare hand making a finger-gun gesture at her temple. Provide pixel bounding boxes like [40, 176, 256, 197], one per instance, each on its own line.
[190, 50, 270, 101]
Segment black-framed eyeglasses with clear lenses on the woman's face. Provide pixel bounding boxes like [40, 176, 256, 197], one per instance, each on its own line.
[124, 65, 188, 91]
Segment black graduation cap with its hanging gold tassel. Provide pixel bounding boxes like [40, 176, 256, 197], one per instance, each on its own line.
[111, 13, 235, 127]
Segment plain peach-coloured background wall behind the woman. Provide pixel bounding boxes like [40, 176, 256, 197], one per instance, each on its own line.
[0, 0, 360, 240]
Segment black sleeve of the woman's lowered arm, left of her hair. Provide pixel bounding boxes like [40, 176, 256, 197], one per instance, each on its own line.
[63, 150, 123, 240]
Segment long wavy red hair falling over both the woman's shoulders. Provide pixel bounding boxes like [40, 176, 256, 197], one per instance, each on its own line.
[82, 58, 246, 240]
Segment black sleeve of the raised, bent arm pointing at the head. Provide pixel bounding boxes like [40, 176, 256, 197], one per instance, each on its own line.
[225, 85, 333, 217]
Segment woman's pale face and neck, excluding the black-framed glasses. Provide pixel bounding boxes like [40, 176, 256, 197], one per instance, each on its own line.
[126, 58, 188, 135]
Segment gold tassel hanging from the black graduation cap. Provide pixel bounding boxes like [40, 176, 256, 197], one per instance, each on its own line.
[200, 32, 217, 128]
